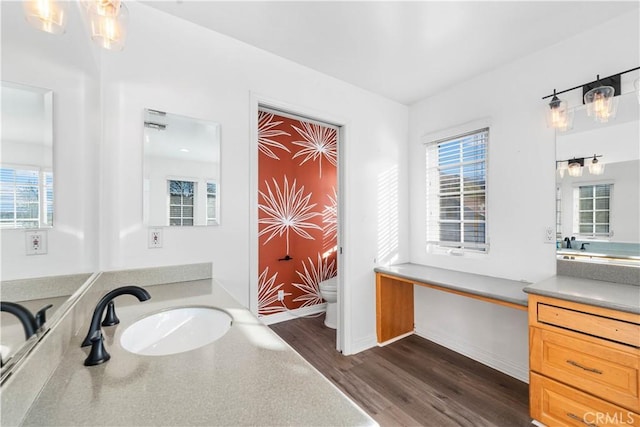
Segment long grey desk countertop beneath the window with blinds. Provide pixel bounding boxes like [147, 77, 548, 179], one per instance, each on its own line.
[374, 263, 530, 307]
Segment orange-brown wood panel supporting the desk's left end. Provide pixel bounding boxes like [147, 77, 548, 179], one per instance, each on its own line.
[376, 273, 414, 343]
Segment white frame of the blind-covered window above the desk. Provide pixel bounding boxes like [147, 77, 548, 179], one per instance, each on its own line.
[421, 118, 491, 257]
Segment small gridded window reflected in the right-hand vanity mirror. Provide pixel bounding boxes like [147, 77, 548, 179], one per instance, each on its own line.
[573, 184, 613, 237]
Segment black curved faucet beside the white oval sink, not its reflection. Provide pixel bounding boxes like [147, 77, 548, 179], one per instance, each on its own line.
[82, 286, 151, 366]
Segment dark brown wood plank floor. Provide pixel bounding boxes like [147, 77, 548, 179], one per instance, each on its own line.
[271, 317, 532, 427]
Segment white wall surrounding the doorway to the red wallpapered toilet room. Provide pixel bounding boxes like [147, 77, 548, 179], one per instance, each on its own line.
[100, 3, 408, 352]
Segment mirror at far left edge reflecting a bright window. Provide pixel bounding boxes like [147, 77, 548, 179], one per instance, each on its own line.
[0, 81, 53, 229]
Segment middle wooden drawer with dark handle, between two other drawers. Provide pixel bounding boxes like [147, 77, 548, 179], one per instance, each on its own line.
[530, 328, 640, 412]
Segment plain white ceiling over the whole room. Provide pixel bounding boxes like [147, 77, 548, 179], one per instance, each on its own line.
[143, 0, 640, 104]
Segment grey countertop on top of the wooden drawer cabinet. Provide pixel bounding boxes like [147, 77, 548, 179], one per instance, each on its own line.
[524, 276, 640, 314]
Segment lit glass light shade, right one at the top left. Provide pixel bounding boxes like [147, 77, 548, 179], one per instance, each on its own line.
[87, 1, 129, 51]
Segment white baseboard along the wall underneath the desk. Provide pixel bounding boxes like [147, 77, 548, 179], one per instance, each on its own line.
[416, 328, 529, 384]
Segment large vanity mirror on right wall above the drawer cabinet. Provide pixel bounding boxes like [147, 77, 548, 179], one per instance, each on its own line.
[556, 92, 640, 265]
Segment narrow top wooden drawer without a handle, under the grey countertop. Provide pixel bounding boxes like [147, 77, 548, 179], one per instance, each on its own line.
[537, 303, 640, 347]
